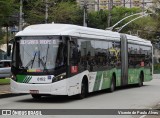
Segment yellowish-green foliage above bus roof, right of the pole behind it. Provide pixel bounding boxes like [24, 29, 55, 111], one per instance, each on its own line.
[49, 2, 83, 25]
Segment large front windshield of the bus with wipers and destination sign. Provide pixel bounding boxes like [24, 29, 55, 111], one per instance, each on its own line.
[13, 36, 67, 72]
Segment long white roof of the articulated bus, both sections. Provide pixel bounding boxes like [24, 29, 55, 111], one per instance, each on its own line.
[16, 24, 151, 45]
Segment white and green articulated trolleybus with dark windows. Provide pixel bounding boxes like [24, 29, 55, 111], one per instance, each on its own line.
[11, 24, 152, 98]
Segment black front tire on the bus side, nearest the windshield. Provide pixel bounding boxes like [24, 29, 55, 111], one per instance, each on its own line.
[78, 81, 88, 99]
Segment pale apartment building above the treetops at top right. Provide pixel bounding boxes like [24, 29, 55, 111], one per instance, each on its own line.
[77, 0, 152, 11]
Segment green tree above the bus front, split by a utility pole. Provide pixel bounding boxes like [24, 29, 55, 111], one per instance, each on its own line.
[24, 0, 82, 24]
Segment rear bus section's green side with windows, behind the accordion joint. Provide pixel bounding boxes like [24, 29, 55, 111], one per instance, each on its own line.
[128, 43, 152, 84]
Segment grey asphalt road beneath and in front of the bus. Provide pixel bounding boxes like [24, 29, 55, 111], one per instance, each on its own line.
[0, 75, 160, 118]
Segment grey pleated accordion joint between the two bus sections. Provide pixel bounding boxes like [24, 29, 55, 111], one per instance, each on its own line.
[121, 34, 128, 86]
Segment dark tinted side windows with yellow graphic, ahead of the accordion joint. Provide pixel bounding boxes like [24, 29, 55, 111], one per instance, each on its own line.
[78, 39, 121, 71]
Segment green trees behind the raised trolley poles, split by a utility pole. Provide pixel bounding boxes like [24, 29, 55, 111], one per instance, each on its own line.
[88, 7, 140, 29]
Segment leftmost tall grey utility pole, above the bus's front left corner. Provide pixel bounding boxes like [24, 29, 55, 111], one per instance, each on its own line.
[19, 0, 23, 31]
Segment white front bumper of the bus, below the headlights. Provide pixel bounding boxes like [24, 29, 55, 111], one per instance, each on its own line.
[11, 79, 68, 95]
